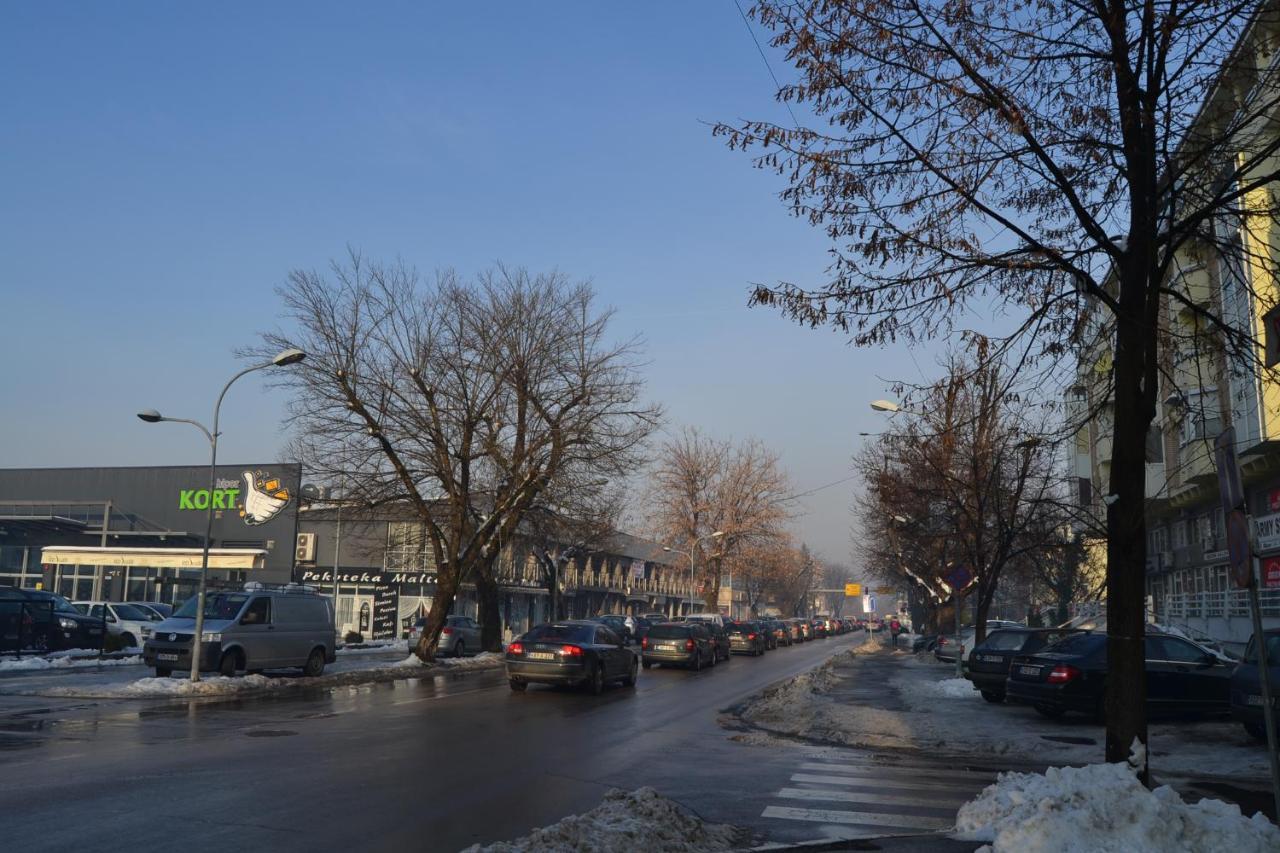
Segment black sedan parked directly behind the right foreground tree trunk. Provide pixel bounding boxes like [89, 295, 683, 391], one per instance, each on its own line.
[1005, 631, 1231, 720]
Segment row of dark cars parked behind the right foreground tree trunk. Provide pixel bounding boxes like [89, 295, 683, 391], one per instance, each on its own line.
[952, 626, 1280, 740]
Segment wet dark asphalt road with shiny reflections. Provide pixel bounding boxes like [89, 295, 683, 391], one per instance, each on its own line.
[0, 635, 947, 850]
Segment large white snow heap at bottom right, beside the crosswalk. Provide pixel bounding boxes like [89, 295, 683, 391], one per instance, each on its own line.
[956, 744, 1280, 853]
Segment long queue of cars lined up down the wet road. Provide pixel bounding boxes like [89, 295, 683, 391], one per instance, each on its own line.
[504, 613, 854, 694]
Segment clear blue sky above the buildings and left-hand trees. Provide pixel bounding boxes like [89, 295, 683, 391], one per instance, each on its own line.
[0, 0, 933, 560]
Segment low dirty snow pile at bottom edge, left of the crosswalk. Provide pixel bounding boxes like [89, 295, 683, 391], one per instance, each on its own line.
[462, 788, 740, 853]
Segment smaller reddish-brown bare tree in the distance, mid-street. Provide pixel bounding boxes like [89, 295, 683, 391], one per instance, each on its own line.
[650, 429, 791, 610]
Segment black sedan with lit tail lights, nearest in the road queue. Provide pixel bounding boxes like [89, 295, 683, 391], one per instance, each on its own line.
[506, 620, 640, 695]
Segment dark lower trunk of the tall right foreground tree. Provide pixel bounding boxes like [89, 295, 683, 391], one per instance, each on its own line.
[1106, 297, 1155, 784]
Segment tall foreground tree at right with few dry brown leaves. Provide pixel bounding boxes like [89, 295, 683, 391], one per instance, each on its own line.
[716, 0, 1280, 779]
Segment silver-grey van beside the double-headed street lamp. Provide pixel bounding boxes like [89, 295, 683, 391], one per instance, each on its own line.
[142, 583, 337, 678]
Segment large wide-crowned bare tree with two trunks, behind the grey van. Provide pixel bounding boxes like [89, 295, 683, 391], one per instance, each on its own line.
[256, 254, 660, 660]
